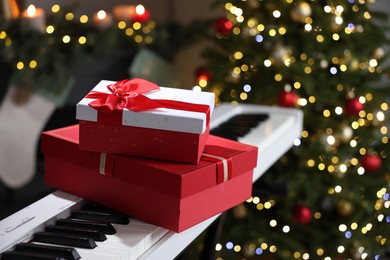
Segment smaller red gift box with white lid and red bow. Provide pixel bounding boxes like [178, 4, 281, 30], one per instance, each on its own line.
[76, 79, 214, 163]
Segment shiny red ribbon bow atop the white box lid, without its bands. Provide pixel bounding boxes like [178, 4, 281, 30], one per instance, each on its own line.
[86, 78, 163, 114]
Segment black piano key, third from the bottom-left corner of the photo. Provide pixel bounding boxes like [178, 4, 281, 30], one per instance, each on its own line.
[33, 232, 96, 248]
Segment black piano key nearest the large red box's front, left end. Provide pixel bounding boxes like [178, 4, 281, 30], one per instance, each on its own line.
[71, 210, 129, 225]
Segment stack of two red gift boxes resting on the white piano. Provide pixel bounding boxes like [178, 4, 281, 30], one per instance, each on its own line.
[42, 79, 257, 232]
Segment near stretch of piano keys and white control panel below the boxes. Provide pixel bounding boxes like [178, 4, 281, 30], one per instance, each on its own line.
[0, 191, 168, 260]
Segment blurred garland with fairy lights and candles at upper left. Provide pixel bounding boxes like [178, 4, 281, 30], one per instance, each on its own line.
[0, 4, 156, 99]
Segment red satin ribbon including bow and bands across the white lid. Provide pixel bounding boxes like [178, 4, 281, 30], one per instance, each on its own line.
[86, 78, 210, 124]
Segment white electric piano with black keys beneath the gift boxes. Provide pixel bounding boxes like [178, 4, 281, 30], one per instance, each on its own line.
[0, 104, 303, 260]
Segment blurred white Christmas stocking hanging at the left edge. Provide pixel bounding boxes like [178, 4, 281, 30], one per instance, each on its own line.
[0, 86, 56, 188]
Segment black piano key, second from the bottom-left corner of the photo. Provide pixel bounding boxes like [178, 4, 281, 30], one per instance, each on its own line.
[14, 243, 80, 260]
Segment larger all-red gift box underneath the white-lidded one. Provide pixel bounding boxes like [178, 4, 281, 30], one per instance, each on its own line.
[42, 125, 257, 232]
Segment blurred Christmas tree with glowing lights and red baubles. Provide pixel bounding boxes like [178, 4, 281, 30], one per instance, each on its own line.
[196, 0, 390, 259]
